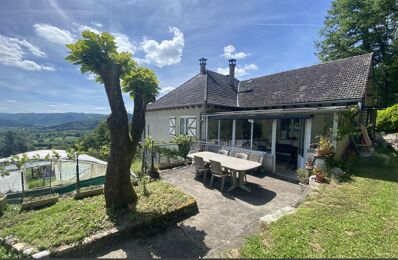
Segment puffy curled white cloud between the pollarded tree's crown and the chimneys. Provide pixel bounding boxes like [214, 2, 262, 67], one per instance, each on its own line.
[141, 27, 184, 67]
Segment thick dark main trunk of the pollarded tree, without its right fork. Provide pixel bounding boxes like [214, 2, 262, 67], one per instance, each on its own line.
[102, 70, 137, 209]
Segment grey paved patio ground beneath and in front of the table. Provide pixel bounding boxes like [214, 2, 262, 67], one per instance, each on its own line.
[87, 167, 306, 258]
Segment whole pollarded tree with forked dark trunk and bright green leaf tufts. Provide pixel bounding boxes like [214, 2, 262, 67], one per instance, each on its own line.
[66, 31, 157, 208]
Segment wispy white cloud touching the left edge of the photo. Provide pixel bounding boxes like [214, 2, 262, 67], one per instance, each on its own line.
[0, 34, 55, 71]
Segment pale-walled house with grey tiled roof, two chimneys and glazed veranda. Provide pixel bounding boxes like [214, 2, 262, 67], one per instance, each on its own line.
[145, 54, 375, 177]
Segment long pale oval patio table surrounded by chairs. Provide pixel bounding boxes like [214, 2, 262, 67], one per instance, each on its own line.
[188, 152, 261, 192]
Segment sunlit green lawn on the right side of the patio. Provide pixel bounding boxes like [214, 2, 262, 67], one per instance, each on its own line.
[239, 152, 398, 258]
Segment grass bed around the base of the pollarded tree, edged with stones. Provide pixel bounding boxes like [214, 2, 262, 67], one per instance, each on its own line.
[0, 181, 193, 250]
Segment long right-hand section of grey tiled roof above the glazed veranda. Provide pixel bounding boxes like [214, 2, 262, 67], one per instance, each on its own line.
[239, 53, 372, 107]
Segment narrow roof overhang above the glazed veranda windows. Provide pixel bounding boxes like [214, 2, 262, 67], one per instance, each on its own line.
[203, 106, 349, 120]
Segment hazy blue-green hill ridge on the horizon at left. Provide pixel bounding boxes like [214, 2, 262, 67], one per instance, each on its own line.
[0, 113, 107, 130]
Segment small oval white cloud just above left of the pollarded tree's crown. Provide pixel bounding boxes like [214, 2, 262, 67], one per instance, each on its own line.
[33, 23, 75, 45]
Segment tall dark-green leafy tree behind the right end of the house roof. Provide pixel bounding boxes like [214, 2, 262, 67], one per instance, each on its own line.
[316, 0, 398, 105]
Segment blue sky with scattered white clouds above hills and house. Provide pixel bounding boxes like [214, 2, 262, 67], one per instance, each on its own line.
[0, 0, 331, 114]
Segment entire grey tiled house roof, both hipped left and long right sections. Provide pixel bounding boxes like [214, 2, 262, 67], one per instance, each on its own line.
[147, 53, 372, 110]
